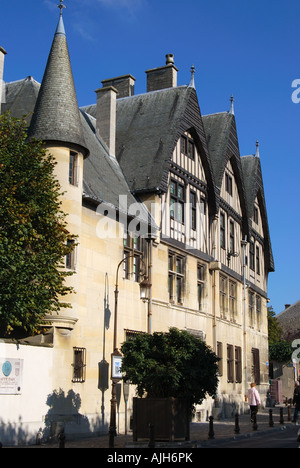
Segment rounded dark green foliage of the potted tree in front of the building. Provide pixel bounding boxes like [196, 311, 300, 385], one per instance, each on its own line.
[121, 328, 218, 409]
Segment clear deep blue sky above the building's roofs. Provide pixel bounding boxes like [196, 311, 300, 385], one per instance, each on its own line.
[0, 0, 300, 313]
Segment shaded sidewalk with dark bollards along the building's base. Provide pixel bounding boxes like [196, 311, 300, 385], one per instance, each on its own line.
[20, 405, 295, 449]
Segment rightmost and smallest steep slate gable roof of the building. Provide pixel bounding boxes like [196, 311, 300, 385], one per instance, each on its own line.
[241, 155, 275, 271]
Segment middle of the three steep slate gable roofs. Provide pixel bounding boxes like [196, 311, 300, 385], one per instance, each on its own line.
[202, 112, 249, 235]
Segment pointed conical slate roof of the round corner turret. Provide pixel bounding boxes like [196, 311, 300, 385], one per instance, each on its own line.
[28, 10, 89, 156]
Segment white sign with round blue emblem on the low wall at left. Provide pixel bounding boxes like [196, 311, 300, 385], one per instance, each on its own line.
[0, 357, 23, 395]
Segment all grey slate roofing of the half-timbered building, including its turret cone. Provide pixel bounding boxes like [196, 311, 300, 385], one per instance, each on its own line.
[3, 11, 274, 256]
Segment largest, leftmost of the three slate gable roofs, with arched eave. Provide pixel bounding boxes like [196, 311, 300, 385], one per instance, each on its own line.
[83, 86, 216, 211]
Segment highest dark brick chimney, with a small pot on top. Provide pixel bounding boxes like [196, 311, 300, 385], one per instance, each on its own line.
[146, 54, 178, 92]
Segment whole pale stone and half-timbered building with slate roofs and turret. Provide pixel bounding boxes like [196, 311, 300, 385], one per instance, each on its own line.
[0, 8, 274, 446]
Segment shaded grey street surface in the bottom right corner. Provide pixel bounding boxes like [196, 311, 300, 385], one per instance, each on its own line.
[208, 426, 300, 448]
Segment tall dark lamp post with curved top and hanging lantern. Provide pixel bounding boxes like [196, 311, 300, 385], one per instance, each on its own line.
[109, 254, 149, 448]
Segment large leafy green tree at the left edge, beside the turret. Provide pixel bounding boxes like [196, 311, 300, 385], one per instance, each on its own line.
[0, 114, 74, 336]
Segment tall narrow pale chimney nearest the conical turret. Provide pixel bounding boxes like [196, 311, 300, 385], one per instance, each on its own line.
[95, 86, 118, 156]
